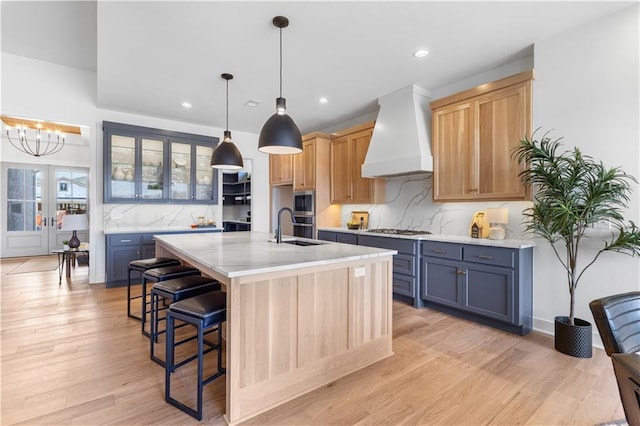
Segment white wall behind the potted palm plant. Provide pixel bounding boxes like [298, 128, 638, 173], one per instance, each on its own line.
[533, 5, 640, 341]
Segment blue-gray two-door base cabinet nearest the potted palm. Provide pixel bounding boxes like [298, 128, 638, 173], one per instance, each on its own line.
[421, 241, 533, 334]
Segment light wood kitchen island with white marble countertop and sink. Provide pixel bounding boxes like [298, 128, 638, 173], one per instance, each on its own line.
[155, 232, 396, 424]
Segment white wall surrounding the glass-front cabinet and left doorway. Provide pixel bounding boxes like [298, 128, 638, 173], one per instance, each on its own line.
[0, 52, 269, 283]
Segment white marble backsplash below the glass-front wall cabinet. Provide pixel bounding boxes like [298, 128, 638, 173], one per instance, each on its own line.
[103, 204, 221, 232]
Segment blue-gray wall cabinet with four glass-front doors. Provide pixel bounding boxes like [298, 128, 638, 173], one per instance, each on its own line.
[103, 121, 218, 204]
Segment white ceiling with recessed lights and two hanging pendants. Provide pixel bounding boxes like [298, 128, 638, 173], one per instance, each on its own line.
[1, 0, 637, 133]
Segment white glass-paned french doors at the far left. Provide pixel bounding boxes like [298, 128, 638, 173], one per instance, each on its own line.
[1, 163, 89, 257]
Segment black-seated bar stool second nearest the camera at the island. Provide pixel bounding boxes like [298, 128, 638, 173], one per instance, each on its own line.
[149, 275, 221, 367]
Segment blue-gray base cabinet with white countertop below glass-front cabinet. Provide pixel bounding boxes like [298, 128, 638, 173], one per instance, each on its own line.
[105, 228, 221, 287]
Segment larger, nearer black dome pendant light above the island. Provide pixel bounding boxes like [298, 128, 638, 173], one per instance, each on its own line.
[258, 16, 302, 154]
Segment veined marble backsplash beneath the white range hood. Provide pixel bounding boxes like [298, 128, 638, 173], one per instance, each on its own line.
[341, 174, 532, 239]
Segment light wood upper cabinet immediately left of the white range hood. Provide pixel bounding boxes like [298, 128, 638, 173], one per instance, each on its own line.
[331, 122, 384, 204]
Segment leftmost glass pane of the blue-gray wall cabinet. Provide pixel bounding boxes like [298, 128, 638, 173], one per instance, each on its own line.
[111, 135, 136, 199]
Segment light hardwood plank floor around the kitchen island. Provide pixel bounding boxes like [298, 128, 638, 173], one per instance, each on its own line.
[0, 258, 624, 425]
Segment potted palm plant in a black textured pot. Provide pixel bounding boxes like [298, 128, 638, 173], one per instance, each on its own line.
[514, 132, 640, 358]
